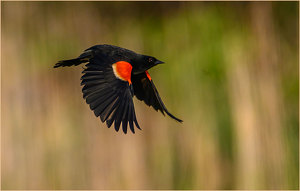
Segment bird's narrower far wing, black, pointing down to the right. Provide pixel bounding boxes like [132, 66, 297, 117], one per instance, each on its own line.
[131, 71, 182, 122]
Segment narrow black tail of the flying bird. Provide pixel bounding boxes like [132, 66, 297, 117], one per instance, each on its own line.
[54, 50, 93, 68]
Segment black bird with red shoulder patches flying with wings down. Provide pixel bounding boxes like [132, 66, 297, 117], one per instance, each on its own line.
[54, 45, 182, 133]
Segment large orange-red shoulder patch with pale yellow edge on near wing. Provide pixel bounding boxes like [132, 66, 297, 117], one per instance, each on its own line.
[112, 61, 132, 84]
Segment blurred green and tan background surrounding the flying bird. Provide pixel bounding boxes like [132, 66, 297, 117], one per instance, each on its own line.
[1, 2, 299, 190]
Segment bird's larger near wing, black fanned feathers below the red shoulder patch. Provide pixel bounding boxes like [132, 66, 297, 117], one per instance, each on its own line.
[81, 49, 140, 133]
